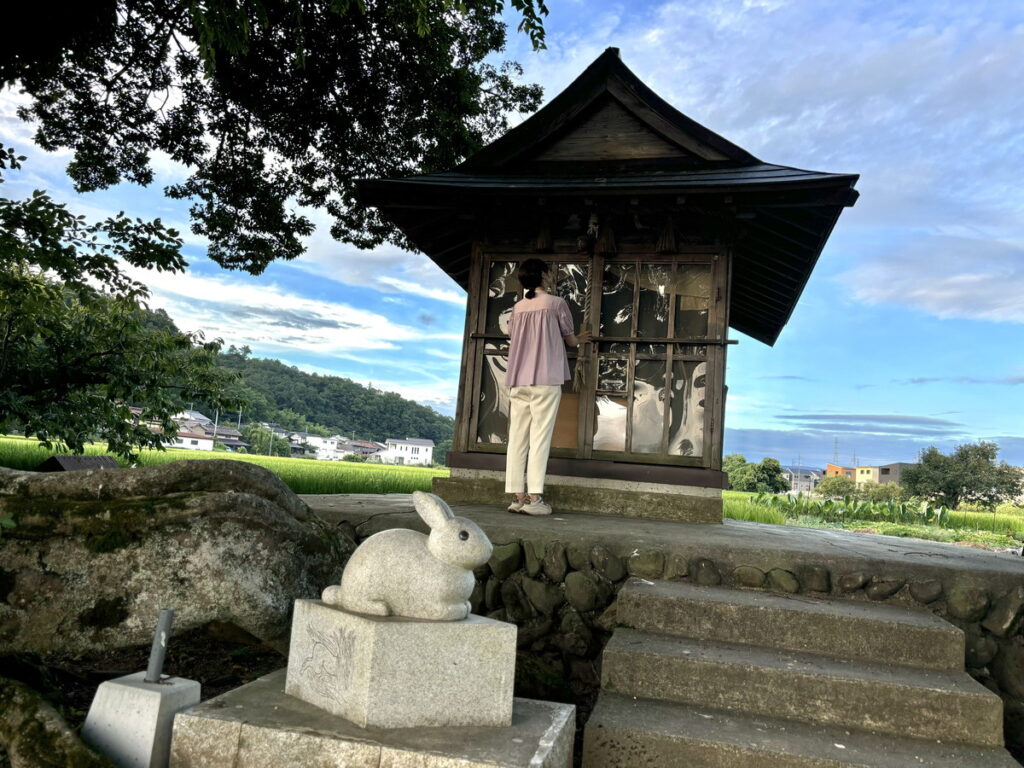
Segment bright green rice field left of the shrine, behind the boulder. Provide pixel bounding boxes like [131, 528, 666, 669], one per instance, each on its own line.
[0, 436, 449, 494]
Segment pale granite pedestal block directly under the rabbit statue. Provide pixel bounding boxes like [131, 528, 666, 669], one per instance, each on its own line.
[285, 600, 516, 728]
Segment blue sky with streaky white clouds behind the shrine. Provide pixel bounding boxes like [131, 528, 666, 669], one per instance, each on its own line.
[0, 0, 1024, 465]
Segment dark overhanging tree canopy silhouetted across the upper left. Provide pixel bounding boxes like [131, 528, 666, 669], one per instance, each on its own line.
[0, 0, 547, 273]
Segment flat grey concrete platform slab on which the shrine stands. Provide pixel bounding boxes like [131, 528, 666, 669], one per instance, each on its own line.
[301, 494, 1024, 600]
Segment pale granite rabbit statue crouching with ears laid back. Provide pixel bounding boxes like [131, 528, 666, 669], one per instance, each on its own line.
[324, 490, 494, 622]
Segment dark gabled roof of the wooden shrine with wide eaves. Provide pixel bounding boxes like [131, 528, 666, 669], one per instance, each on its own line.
[358, 48, 858, 344]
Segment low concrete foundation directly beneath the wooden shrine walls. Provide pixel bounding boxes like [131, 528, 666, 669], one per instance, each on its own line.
[433, 469, 722, 523]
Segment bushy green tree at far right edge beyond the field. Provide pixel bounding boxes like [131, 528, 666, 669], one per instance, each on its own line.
[902, 441, 1024, 509]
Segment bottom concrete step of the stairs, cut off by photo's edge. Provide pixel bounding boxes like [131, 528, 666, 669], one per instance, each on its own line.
[583, 692, 1020, 768]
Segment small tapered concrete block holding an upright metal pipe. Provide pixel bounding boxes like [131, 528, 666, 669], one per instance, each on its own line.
[82, 672, 200, 768]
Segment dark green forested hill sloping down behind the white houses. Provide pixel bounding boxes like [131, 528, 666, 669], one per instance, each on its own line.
[210, 347, 455, 443]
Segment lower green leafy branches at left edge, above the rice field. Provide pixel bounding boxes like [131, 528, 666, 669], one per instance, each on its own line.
[0, 145, 231, 456]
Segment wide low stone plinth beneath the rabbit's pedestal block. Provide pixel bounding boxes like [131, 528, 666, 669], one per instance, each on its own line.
[171, 670, 575, 768]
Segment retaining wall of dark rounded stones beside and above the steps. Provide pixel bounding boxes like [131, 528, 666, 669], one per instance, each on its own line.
[346, 538, 1024, 758]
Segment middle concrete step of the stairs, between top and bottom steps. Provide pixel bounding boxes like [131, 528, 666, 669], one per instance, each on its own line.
[601, 628, 1002, 746]
